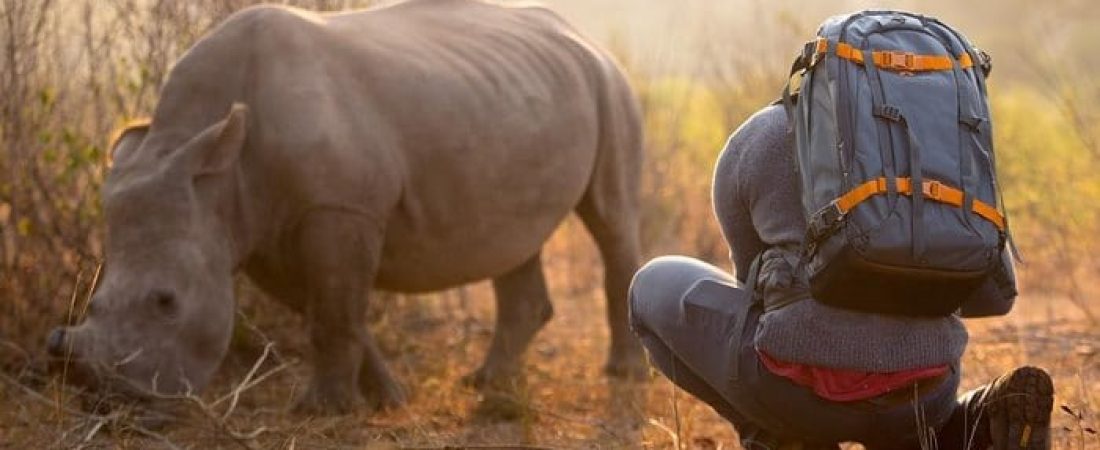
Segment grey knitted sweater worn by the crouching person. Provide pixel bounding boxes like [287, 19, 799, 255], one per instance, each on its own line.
[713, 106, 967, 372]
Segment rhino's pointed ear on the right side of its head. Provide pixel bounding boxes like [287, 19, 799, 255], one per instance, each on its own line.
[189, 103, 249, 176]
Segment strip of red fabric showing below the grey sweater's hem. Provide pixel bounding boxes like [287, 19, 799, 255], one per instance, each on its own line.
[757, 351, 948, 402]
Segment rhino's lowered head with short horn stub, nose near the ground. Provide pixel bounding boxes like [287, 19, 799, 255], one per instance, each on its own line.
[46, 105, 248, 398]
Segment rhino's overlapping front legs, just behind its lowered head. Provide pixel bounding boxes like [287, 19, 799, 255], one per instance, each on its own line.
[297, 212, 405, 414]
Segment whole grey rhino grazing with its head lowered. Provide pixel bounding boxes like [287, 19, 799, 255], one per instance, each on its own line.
[46, 0, 646, 414]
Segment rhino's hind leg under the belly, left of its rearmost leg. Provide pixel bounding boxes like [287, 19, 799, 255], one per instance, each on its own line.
[465, 253, 553, 391]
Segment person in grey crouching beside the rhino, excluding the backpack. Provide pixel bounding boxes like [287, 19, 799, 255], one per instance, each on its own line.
[629, 106, 1053, 449]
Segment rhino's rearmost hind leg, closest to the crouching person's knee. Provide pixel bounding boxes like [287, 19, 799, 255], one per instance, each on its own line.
[576, 189, 649, 380]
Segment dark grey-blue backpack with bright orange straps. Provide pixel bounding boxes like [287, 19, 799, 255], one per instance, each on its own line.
[783, 11, 1011, 316]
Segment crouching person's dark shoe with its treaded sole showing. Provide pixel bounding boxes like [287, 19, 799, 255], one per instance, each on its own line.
[981, 366, 1054, 450]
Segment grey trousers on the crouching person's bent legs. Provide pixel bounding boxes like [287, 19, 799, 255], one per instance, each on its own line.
[630, 256, 974, 449]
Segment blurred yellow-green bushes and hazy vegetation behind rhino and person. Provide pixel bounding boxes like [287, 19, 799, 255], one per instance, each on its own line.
[0, 0, 1100, 369]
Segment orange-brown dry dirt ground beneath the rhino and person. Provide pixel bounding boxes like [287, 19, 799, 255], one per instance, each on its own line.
[0, 229, 1100, 449]
